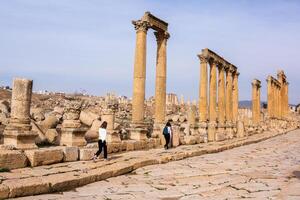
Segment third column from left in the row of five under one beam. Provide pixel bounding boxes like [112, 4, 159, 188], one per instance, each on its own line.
[218, 65, 225, 124]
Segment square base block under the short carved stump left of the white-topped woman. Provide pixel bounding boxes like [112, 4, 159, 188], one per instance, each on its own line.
[60, 128, 87, 147]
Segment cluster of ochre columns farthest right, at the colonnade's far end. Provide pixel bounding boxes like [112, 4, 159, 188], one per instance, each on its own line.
[267, 71, 289, 119]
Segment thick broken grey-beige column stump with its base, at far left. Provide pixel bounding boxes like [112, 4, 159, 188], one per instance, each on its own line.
[4, 78, 38, 149]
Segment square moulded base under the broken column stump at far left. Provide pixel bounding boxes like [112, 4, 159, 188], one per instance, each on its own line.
[4, 130, 38, 150]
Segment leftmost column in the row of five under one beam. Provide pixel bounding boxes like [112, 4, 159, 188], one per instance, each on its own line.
[198, 55, 208, 122]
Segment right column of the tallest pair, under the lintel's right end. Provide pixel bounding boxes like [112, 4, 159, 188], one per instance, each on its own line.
[154, 31, 170, 123]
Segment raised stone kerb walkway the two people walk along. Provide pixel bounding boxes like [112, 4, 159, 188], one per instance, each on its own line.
[0, 129, 294, 199]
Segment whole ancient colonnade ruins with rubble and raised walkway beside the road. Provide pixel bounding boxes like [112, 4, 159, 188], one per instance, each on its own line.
[0, 12, 300, 199]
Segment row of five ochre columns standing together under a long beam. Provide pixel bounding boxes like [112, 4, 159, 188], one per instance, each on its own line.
[198, 54, 239, 141]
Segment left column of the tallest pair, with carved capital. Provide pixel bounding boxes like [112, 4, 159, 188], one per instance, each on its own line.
[132, 20, 149, 123]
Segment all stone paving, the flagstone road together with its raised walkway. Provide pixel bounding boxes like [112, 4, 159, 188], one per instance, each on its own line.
[0, 127, 300, 200]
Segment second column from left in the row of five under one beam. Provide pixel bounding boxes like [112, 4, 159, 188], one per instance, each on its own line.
[207, 58, 217, 141]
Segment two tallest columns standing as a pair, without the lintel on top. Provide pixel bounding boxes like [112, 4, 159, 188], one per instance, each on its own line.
[132, 20, 169, 124]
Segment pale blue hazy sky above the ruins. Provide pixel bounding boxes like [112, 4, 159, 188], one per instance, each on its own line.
[0, 0, 300, 104]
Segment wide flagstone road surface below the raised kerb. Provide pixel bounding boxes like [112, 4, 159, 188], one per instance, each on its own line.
[14, 130, 300, 200]
